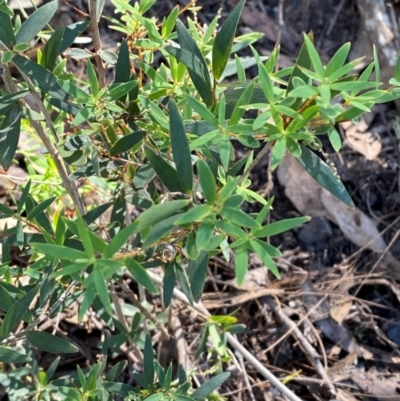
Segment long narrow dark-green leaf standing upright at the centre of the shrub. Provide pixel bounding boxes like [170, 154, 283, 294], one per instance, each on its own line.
[168, 98, 193, 194]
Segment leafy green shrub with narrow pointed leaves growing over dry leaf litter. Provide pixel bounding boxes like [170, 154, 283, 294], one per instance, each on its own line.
[0, 0, 400, 401]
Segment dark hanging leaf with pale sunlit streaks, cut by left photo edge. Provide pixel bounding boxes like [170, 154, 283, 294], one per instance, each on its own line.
[0, 104, 21, 170]
